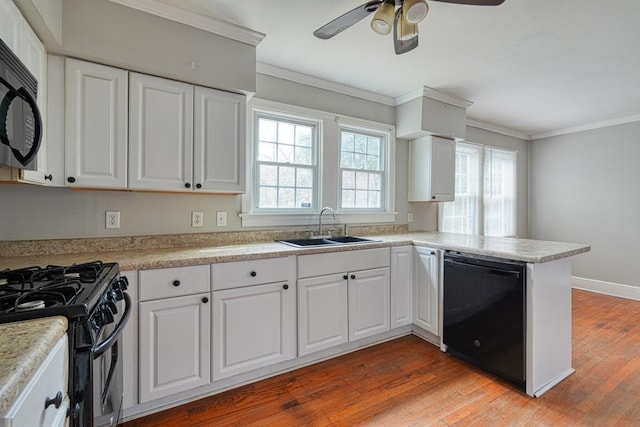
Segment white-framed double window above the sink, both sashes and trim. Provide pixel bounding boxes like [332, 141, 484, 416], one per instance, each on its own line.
[240, 98, 396, 228]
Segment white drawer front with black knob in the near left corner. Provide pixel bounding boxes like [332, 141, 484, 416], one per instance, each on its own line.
[0, 334, 69, 426]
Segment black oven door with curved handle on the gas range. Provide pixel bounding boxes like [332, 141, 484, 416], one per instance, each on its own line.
[93, 293, 131, 427]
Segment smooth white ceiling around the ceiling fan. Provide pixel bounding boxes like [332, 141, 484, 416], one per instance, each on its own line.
[151, 0, 640, 137]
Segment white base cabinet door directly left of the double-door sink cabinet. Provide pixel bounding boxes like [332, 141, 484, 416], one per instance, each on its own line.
[212, 282, 296, 381]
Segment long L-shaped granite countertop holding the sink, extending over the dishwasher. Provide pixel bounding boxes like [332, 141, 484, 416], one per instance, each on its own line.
[0, 232, 591, 271]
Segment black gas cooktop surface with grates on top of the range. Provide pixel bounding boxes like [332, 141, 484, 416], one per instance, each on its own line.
[0, 261, 119, 323]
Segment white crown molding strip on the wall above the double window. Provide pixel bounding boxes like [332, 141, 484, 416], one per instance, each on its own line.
[255, 63, 396, 107]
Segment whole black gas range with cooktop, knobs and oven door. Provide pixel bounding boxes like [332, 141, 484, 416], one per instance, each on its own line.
[0, 261, 131, 427]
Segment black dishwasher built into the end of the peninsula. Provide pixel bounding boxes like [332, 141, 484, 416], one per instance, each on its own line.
[442, 251, 526, 388]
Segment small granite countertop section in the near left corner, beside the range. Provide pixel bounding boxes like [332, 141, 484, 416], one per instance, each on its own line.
[0, 316, 67, 413]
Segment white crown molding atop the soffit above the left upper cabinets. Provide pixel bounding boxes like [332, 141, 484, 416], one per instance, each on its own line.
[109, 0, 265, 46]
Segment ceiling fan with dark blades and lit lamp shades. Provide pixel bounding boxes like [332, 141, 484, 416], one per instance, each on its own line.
[313, 0, 504, 55]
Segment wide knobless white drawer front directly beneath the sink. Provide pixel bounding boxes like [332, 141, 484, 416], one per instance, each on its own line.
[298, 248, 390, 279]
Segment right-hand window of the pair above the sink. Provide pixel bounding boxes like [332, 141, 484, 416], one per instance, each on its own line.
[340, 128, 386, 210]
